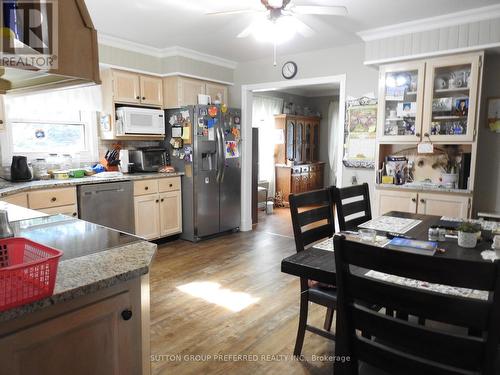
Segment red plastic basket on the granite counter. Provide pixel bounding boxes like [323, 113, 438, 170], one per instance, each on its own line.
[0, 237, 63, 311]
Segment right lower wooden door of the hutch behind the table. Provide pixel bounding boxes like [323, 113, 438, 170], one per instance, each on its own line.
[418, 193, 470, 219]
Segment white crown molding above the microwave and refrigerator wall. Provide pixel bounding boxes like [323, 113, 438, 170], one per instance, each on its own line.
[98, 33, 238, 69]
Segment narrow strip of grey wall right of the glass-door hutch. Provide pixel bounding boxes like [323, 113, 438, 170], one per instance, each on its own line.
[474, 55, 500, 216]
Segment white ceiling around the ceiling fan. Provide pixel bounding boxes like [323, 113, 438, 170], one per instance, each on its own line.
[85, 0, 498, 62]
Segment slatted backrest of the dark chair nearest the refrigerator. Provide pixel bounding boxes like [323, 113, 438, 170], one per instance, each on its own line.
[288, 187, 335, 252]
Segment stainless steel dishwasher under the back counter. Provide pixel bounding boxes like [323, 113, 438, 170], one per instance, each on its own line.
[78, 181, 135, 234]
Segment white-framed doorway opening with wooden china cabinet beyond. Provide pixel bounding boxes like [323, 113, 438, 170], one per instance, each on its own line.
[241, 75, 345, 237]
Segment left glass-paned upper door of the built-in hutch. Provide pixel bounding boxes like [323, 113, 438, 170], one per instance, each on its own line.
[377, 62, 425, 142]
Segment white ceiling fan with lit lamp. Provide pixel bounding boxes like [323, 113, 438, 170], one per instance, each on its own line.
[206, 0, 347, 66]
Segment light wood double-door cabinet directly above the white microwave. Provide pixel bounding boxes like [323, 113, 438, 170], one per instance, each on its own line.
[111, 69, 163, 107]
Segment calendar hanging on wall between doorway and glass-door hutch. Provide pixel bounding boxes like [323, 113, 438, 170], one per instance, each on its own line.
[343, 97, 377, 169]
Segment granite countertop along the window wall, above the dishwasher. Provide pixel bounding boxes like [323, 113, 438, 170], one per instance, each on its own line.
[0, 172, 184, 197]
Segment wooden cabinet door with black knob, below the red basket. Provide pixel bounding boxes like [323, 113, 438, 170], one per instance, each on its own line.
[0, 292, 141, 375]
